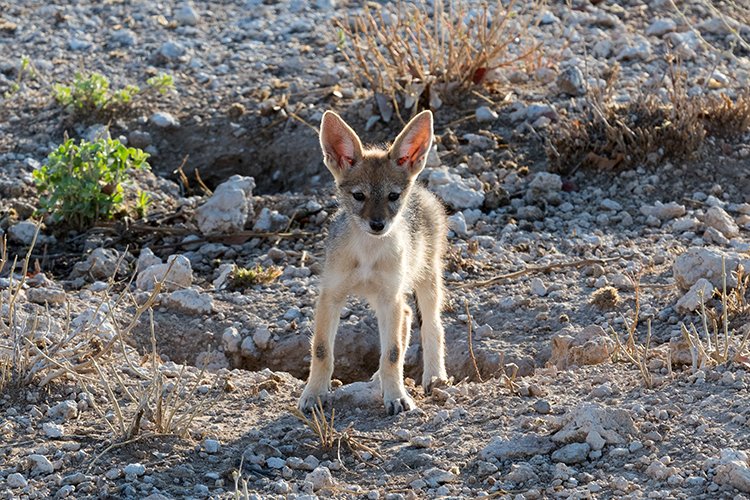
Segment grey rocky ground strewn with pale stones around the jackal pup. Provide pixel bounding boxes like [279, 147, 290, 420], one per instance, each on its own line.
[0, 0, 750, 499]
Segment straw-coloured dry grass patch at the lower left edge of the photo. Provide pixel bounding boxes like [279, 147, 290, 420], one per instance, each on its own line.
[0, 232, 221, 456]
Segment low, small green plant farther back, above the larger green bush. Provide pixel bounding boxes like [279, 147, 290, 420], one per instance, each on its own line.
[53, 73, 174, 115]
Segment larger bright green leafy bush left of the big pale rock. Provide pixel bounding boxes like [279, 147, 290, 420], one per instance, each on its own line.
[33, 139, 149, 229]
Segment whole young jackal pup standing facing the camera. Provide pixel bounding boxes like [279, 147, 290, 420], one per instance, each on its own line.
[299, 111, 447, 415]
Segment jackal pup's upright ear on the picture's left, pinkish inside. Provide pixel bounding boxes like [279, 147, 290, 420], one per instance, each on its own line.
[320, 111, 362, 176]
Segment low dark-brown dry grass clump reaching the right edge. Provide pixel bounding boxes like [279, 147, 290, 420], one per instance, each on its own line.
[547, 67, 750, 174]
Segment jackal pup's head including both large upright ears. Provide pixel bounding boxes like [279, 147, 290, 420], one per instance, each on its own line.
[320, 111, 432, 236]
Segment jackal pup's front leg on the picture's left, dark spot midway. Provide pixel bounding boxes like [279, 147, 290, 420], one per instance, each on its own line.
[299, 291, 344, 411]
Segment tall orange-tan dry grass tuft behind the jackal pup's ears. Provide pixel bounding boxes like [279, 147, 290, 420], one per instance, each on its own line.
[335, 0, 541, 115]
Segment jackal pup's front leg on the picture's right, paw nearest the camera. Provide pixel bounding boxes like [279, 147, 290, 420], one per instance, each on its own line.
[376, 297, 415, 415]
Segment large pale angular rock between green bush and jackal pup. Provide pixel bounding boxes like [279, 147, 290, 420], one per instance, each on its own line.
[195, 175, 255, 235]
